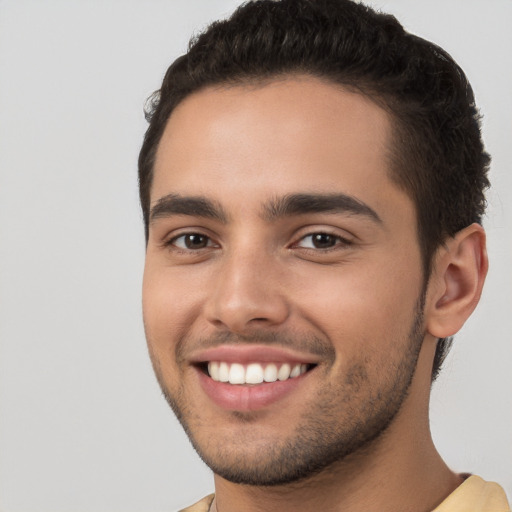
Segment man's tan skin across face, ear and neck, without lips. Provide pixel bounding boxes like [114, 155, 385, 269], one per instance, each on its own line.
[143, 76, 487, 512]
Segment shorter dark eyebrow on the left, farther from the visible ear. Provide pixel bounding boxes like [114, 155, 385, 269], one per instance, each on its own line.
[149, 194, 228, 224]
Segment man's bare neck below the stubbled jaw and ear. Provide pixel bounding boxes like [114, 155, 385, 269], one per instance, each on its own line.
[212, 338, 462, 512]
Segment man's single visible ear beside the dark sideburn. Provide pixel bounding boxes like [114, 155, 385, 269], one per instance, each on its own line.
[425, 224, 488, 338]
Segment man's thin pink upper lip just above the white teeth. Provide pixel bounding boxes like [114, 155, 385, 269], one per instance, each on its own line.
[188, 344, 319, 364]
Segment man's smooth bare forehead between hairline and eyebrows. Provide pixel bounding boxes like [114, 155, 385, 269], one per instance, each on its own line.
[151, 77, 399, 218]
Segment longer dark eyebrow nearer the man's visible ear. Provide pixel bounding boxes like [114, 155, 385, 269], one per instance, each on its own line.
[263, 194, 382, 224]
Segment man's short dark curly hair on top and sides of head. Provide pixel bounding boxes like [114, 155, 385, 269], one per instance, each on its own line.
[139, 0, 490, 379]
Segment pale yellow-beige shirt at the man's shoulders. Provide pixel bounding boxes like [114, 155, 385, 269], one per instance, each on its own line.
[180, 475, 511, 512]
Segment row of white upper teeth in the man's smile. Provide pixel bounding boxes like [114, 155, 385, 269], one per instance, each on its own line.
[199, 361, 316, 385]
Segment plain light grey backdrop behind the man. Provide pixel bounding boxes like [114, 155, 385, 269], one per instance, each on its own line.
[0, 0, 512, 512]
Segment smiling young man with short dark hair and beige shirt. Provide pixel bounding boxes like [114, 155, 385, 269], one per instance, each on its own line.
[139, 0, 510, 512]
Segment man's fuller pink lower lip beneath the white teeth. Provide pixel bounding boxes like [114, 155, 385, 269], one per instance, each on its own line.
[197, 369, 309, 411]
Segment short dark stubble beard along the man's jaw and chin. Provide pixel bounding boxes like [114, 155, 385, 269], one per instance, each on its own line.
[153, 294, 424, 486]
